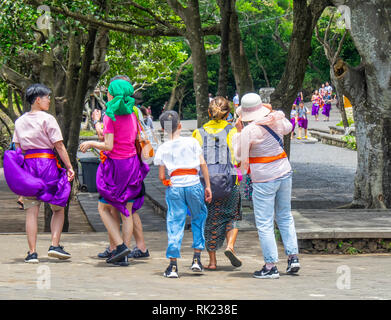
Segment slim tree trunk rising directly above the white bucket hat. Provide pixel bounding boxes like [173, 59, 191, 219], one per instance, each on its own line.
[227, 0, 254, 97]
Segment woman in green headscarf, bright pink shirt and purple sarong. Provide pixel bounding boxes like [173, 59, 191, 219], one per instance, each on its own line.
[80, 79, 149, 265]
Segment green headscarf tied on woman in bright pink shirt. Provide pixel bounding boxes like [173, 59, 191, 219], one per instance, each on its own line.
[106, 79, 135, 121]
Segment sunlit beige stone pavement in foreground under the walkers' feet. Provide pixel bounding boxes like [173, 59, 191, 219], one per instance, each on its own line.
[0, 230, 391, 300]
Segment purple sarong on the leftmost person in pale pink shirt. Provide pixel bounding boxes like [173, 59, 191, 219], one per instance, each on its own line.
[4, 149, 71, 207]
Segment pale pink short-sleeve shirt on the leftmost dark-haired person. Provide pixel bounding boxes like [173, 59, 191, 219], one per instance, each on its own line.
[12, 111, 63, 150]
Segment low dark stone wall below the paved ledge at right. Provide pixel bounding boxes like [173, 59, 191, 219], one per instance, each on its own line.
[298, 239, 391, 254]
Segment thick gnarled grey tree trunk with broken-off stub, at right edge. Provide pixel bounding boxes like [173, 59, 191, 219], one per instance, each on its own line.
[334, 0, 391, 208]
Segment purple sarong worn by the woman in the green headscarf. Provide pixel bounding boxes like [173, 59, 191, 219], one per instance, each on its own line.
[96, 155, 149, 217]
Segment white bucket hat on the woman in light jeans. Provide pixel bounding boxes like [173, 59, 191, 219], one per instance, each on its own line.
[236, 93, 270, 121]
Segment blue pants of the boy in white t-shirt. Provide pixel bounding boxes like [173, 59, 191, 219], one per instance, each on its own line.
[166, 183, 208, 259]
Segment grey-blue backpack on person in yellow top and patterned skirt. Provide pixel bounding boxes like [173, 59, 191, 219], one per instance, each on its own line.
[199, 124, 237, 201]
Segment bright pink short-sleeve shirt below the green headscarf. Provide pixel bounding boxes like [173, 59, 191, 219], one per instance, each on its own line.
[103, 113, 138, 159]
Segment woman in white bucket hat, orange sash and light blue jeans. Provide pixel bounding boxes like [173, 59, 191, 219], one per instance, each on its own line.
[233, 93, 300, 279]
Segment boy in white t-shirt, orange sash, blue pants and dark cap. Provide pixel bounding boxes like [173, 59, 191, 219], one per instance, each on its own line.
[154, 111, 212, 278]
